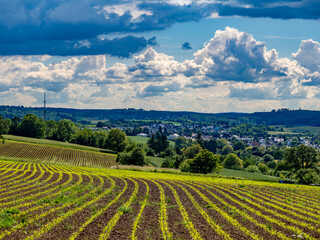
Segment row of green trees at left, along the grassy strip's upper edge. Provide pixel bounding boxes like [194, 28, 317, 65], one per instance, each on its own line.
[0, 114, 128, 152]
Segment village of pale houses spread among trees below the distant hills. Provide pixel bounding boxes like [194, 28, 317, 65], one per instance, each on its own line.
[91, 120, 320, 149]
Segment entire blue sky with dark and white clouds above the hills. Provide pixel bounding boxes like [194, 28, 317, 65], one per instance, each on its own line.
[0, 0, 320, 113]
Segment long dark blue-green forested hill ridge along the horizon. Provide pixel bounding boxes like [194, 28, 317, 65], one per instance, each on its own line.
[0, 106, 320, 126]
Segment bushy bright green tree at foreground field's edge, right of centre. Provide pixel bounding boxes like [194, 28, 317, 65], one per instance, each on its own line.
[189, 149, 219, 174]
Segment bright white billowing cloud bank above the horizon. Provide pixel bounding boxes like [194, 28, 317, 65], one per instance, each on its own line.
[0, 27, 320, 111]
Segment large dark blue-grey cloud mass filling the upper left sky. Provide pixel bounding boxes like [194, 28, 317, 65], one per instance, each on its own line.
[0, 0, 214, 57]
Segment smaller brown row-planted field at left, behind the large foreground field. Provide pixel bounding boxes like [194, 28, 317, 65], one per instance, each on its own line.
[0, 141, 116, 168]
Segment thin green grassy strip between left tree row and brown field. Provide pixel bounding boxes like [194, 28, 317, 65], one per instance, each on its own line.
[3, 135, 115, 153]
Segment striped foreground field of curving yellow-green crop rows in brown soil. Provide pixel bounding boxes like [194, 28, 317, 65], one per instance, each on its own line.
[0, 160, 320, 239]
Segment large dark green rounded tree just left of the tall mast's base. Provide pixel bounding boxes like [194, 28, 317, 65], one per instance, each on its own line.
[18, 114, 46, 138]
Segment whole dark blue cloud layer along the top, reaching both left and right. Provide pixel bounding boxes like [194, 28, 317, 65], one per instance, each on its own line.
[0, 0, 320, 57]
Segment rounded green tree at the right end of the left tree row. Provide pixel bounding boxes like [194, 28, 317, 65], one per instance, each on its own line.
[105, 128, 128, 152]
